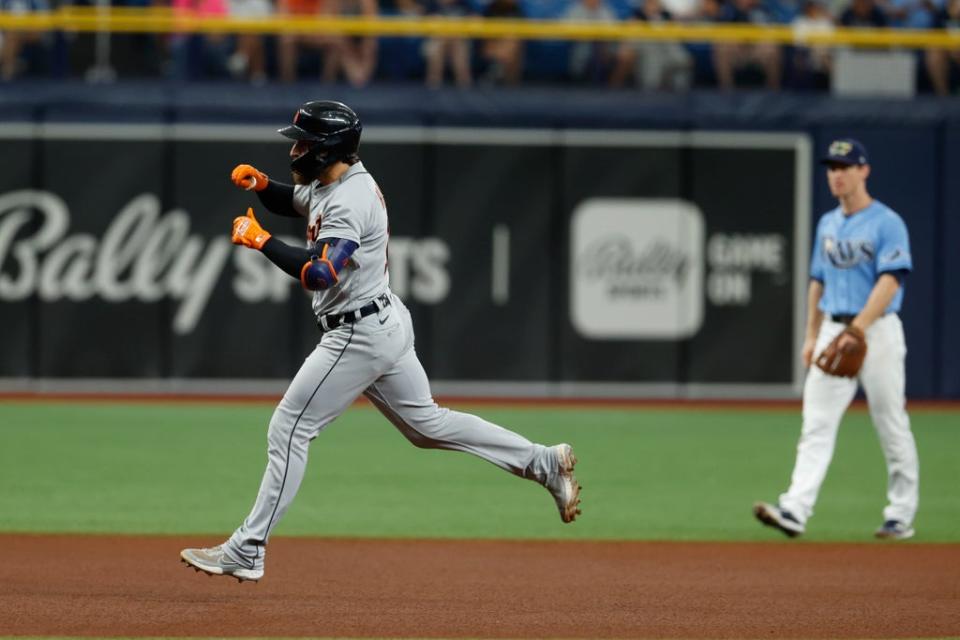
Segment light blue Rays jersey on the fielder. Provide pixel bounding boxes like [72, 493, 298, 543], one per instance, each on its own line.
[810, 200, 913, 315]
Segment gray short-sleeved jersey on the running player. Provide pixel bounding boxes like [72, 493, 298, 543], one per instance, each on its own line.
[293, 162, 390, 318]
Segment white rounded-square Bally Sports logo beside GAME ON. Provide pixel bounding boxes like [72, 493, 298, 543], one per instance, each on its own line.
[570, 198, 704, 340]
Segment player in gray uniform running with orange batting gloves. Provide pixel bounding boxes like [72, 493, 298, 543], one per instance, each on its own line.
[180, 101, 580, 581]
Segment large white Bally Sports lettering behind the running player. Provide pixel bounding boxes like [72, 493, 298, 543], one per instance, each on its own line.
[0, 189, 450, 335]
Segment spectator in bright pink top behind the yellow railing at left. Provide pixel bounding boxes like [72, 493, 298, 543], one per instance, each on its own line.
[170, 0, 230, 80]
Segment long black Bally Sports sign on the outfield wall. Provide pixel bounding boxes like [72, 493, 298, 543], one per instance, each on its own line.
[0, 124, 812, 397]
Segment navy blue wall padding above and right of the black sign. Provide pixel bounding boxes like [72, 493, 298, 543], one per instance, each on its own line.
[0, 82, 960, 398]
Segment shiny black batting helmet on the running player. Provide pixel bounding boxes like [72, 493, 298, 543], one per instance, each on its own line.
[278, 100, 363, 176]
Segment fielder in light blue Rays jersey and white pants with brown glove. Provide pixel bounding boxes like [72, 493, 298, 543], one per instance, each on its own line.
[754, 138, 919, 540]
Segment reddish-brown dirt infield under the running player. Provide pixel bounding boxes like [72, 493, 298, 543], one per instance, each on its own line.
[0, 535, 960, 639]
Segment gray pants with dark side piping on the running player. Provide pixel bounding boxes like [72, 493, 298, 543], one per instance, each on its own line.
[224, 295, 556, 568]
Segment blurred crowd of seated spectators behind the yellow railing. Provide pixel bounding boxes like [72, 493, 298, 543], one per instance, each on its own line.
[0, 0, 960, 95]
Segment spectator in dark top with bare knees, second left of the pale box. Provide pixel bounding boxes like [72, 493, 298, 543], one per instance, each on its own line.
[713, 0, 783, 91]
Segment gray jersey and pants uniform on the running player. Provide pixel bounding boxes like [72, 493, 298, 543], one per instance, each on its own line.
[223, 163, 579, 570]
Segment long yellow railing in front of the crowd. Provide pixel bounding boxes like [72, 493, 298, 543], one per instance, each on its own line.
[0, 8, 960, 49]
